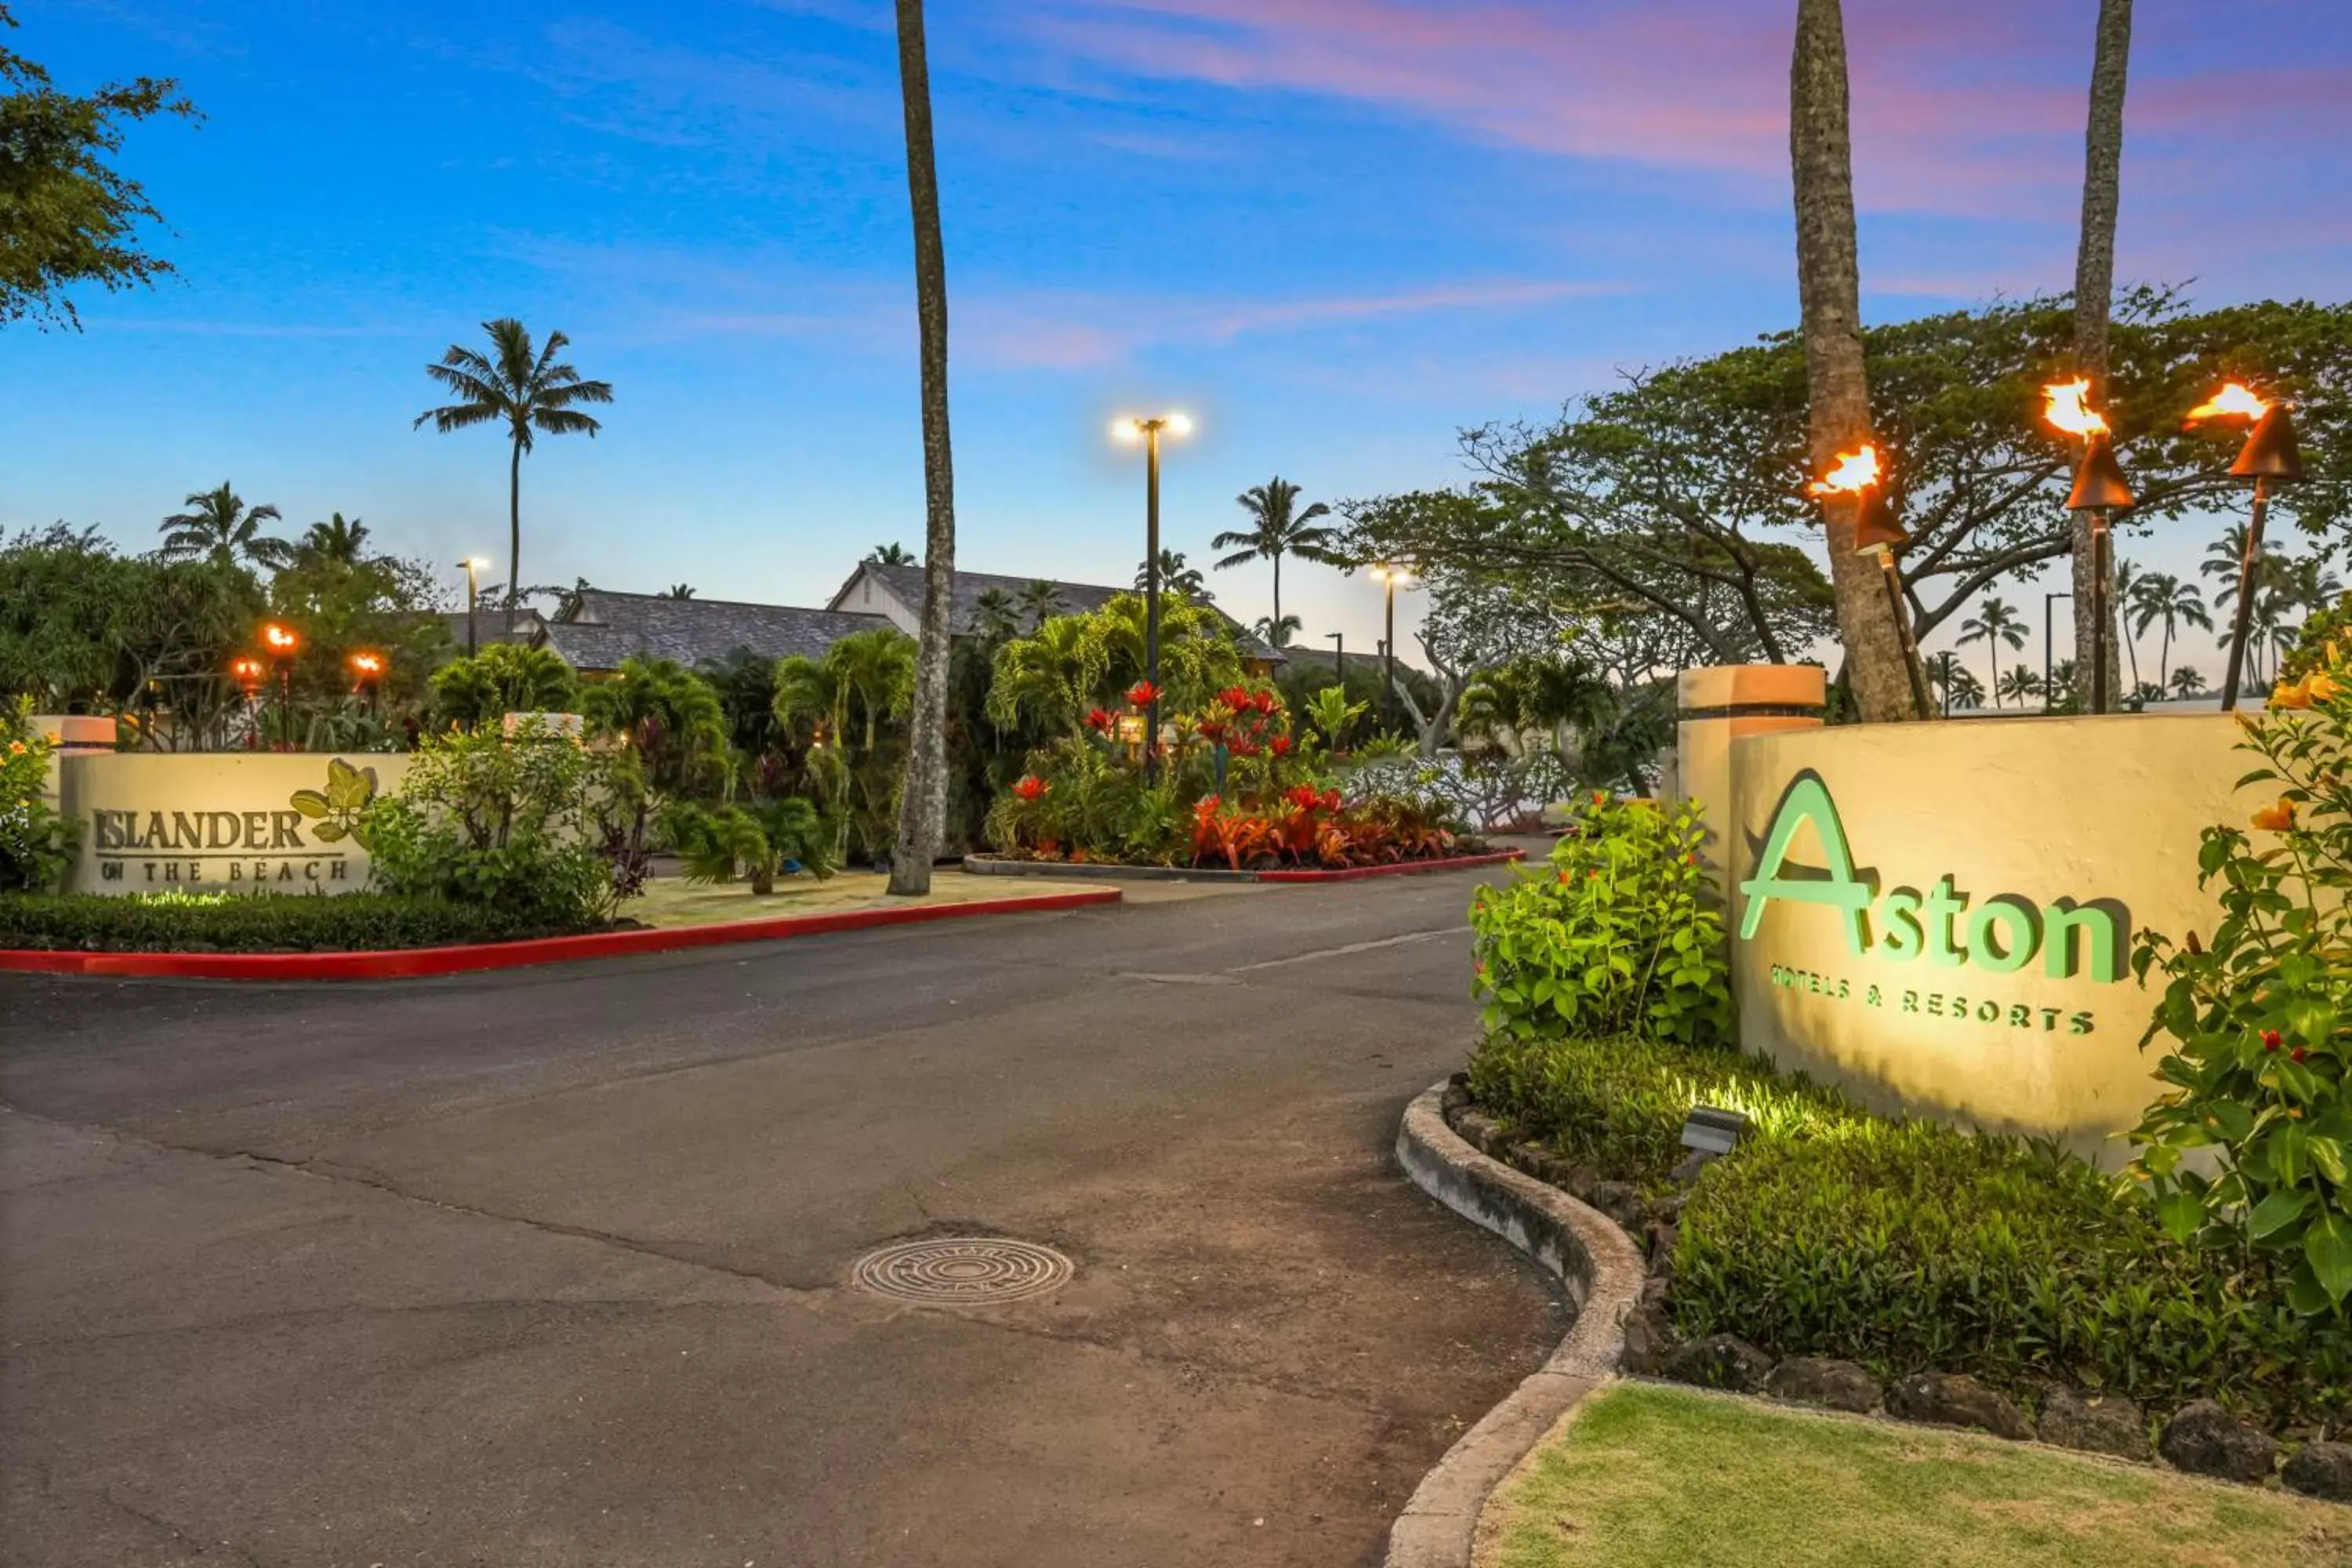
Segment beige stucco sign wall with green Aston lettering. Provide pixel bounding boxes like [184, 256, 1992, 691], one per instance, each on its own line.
[1710, 715, 2251, 1156]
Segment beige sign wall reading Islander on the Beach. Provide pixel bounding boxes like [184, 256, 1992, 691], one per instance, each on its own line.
[59, 753, 409, 893]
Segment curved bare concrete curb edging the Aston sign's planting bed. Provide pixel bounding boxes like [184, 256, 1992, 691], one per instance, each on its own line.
[1385, 1083, 1642, 1568]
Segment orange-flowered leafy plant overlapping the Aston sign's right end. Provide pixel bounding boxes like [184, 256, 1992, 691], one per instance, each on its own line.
[2133, 642, 2352, 1316]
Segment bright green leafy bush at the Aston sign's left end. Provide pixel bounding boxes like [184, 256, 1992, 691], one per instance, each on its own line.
[1470, 792, 1731, 1044]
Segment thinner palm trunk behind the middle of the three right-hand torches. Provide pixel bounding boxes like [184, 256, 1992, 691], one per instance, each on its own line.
[2072, 0, 2131, 710]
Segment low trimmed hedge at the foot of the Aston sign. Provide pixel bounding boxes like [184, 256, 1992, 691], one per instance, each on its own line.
[1470, 1036, 2352, 1432]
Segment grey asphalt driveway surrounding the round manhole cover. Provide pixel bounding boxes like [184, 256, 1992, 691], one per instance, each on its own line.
[0, 874, 1564, 1568]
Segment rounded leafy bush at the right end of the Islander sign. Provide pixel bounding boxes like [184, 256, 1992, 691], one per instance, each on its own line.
[365, 722, 633, 928]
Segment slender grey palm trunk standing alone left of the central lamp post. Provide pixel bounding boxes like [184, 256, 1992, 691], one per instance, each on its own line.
[889, 0, 955, 895]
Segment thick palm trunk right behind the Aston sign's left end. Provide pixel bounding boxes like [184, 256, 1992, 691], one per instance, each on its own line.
[1788, 0, 1926, 722]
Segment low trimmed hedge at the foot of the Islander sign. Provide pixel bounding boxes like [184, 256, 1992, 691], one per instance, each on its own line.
[0, 893, 597, 952]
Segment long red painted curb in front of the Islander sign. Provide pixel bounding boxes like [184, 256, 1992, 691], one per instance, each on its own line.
[0, 888, 1120, 980]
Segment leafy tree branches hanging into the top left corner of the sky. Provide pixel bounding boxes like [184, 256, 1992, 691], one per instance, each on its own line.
[0, 5, 200, 329]
